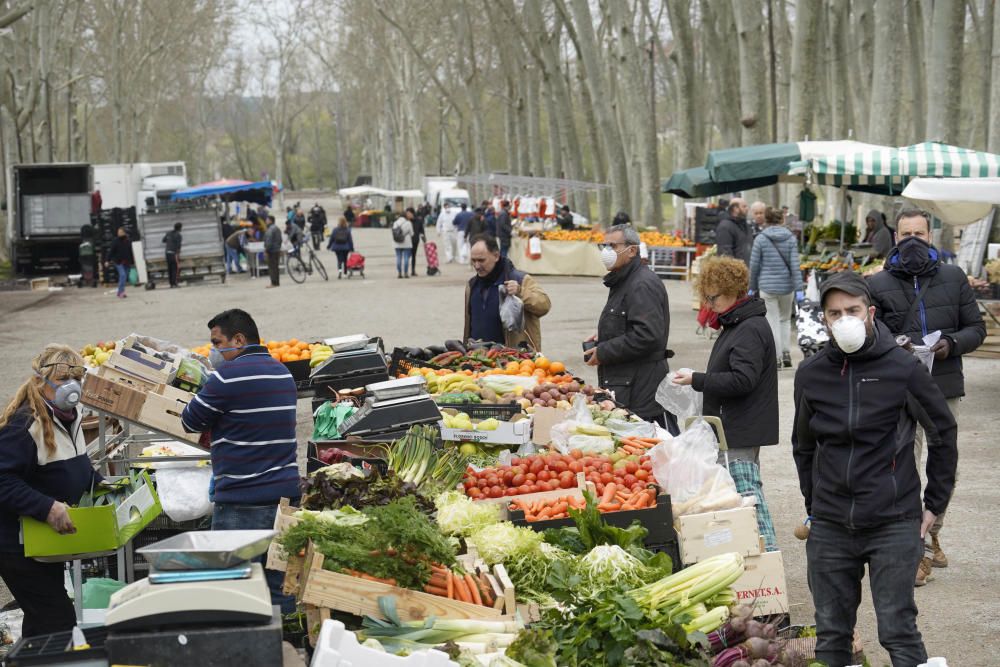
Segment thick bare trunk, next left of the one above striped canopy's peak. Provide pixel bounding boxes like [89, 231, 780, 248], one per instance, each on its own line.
[867, 0, 900, 146]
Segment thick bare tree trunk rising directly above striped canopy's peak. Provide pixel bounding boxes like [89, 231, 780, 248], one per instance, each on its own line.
[927, 0, 965, 142]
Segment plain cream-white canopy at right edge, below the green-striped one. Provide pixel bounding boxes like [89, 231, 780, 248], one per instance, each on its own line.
[903, 178, 1000, 225]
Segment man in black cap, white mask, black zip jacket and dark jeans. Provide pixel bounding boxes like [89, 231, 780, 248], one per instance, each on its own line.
[792, 272, 958, 667]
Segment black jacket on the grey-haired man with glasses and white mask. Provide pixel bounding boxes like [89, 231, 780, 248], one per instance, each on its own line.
[597, 257, 670, 421]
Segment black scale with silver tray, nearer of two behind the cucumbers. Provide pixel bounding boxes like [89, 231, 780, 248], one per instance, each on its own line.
[341, 376, 441, 439]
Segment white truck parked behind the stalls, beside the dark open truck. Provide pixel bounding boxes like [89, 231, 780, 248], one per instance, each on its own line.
[94, 162, 188, 215]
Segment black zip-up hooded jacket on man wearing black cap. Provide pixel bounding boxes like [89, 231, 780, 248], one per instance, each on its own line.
[792, 321, 958, 528]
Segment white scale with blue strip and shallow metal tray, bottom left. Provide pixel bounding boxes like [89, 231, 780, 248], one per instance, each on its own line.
[105, 530, 274, 631]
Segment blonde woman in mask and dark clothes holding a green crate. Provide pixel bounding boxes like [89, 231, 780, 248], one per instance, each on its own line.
[0, 344, 101, 637]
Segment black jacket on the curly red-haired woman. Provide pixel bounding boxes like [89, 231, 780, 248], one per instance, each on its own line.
[691, 298, 778, 447]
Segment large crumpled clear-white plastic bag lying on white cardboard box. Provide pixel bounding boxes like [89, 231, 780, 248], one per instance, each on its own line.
[649, 419, 742, 516]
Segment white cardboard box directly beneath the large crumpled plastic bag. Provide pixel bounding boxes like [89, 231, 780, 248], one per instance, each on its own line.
[674, 507, 761, 565]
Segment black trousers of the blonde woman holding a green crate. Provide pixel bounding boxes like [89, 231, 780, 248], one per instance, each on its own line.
[0, 553, 76, 637]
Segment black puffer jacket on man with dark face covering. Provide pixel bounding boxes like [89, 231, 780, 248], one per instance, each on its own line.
[868, 248, 986, 398]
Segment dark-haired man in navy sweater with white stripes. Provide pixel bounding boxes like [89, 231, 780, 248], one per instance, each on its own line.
[181, 308, 299, 613]
